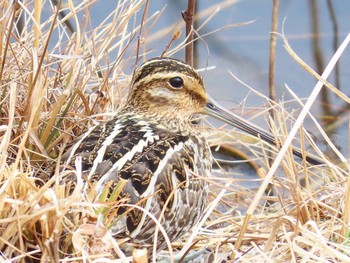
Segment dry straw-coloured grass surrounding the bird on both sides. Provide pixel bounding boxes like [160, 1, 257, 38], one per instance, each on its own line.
[0, 0, 350, 262]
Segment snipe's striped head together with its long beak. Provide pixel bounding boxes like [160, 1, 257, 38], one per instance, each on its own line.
[126, 58, 301, 159]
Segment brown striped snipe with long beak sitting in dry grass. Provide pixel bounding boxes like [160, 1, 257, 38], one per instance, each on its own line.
[61, 57, 320, 254]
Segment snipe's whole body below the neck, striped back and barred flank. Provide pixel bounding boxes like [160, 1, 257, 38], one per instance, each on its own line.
[62, 112, 212, 250]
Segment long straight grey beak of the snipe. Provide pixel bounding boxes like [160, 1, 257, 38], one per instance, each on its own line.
[204, 97, 323, 165]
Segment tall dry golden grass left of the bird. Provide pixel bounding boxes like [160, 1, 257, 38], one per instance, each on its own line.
[0, 1, 142, 262]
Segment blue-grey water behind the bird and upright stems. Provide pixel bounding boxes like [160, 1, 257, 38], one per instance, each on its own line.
[85, 0, 350, 159]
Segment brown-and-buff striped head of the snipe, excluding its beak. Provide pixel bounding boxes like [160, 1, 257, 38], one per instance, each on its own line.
[126, 58, 207, 121]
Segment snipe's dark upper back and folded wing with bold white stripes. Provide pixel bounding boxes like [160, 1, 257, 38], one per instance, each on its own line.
[62, 118, 210, 201]
